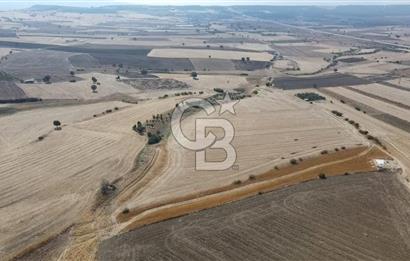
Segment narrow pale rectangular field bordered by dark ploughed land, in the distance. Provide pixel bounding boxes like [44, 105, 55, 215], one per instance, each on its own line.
[148, 48, 273, 62]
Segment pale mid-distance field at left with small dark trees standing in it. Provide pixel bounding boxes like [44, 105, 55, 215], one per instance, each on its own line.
[19, 73, 139, 100]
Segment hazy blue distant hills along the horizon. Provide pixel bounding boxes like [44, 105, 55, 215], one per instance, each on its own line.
[29, 5, 410, 26]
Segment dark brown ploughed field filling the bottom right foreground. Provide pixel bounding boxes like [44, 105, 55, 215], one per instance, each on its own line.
[98, 173, 410, 260]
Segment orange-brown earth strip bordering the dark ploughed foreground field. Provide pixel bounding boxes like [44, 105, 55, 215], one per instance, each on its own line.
[117, 147, 391, 231]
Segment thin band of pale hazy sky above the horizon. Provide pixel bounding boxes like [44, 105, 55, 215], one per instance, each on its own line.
[0, 0, 410, 9]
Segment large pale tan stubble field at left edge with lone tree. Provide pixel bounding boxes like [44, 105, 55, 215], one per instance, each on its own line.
[0, 98, 179, 259]
